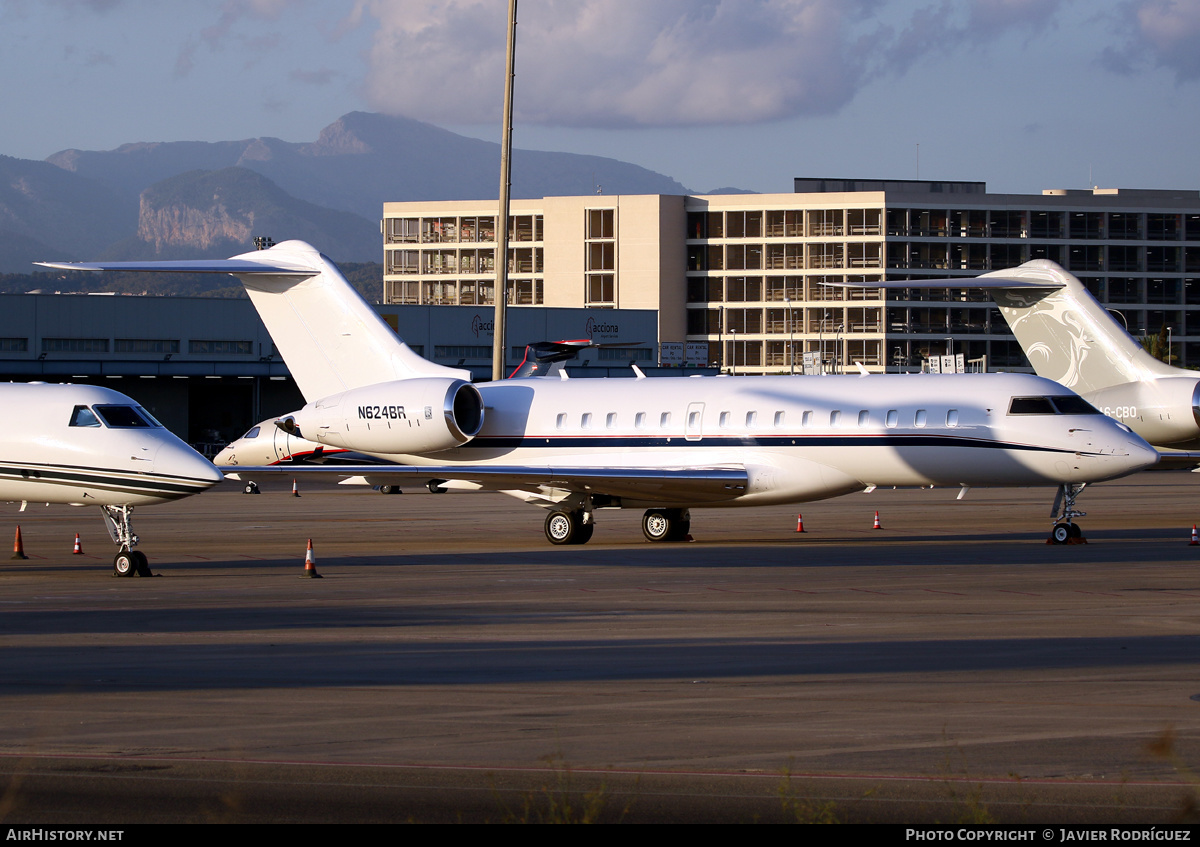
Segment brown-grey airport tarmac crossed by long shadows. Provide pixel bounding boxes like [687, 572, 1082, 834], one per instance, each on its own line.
[0, 471, 1200, 824]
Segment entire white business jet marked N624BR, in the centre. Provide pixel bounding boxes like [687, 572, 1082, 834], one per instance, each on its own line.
[42, 241, 1158, 543]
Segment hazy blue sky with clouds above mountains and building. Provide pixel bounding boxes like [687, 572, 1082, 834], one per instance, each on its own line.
[0, 0, 1200, 192]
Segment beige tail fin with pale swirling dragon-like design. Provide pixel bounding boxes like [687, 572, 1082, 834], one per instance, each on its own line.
[979, 259, 1181, 394]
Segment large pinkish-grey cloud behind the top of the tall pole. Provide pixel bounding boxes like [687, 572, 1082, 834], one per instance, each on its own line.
[342, 0, 1062, 127]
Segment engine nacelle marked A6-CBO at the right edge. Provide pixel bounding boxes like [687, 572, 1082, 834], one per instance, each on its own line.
[1085, 377, 1200, 450]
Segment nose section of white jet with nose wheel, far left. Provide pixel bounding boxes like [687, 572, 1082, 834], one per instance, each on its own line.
[0, 383, 222, 576]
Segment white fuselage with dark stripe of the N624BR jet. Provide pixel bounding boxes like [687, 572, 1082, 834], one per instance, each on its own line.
[260, 374, 1157, 507]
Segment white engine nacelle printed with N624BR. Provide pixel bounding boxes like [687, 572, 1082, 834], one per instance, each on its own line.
[278, 377, 484, 453]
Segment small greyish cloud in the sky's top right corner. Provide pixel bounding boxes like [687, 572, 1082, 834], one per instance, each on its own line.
[1103, 0, 1200, 83]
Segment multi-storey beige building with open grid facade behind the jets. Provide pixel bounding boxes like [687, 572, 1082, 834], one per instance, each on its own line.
[383, 179, 1200, 373]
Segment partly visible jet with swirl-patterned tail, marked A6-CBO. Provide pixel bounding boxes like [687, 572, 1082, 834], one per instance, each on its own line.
[854, 259, 1200, 465]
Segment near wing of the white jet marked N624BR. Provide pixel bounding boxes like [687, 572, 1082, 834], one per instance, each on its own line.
[221, 464, 749, 504]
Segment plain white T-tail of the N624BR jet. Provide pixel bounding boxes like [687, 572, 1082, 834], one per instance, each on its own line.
[38, 241, 470, 402]
